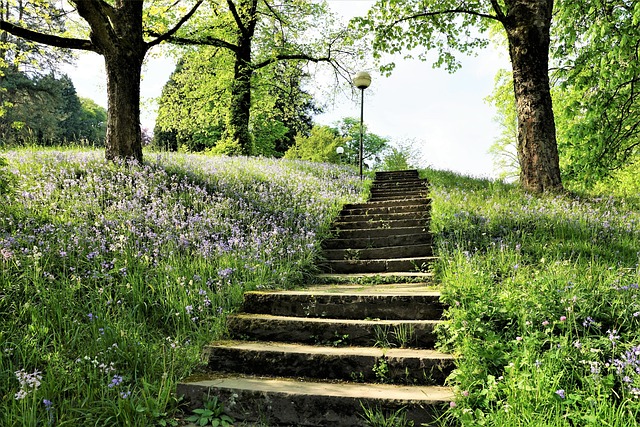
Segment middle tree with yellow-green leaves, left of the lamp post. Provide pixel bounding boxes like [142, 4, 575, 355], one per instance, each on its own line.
[160, 0, 358, 154]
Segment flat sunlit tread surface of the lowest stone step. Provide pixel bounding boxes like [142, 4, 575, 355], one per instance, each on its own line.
[182, 374, 454, 402]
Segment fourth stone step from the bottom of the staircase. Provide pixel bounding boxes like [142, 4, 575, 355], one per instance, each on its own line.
[242, 284, 444, 320]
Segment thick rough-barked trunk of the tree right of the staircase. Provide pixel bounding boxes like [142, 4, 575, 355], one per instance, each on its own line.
[504, 0, 562, 193]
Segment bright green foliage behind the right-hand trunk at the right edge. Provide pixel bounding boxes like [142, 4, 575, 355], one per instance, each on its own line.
[552, 0, 640, 184]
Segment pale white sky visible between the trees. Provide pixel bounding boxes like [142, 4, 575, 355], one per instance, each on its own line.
[63, 0, 510, 178]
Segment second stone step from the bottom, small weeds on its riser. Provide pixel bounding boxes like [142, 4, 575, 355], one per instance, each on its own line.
[204, 337, 454, 385]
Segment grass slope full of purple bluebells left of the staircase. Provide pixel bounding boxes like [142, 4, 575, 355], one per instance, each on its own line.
[0, 150, 363, 426]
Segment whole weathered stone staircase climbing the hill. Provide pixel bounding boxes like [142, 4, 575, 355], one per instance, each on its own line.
[177, 171, 453, 426]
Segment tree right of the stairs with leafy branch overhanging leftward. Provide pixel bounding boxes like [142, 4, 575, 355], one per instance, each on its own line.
[355, 0, 562, 192]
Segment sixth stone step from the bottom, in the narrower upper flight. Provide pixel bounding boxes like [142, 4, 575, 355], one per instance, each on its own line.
[320, 257, 437, 273]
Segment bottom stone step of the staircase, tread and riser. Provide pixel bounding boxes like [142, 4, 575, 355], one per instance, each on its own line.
[177, 375, 454, 427]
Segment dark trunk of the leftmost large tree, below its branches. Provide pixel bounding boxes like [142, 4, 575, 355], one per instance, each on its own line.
[104, 52, 144, 162]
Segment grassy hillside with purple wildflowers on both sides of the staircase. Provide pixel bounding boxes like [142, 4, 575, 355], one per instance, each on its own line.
[0, 151, 640, 427]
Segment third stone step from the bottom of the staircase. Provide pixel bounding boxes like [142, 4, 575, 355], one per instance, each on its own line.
[227, 313, 441, 348]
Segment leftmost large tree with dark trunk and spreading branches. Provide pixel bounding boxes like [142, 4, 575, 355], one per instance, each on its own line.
[0, 0, 204, 161]
